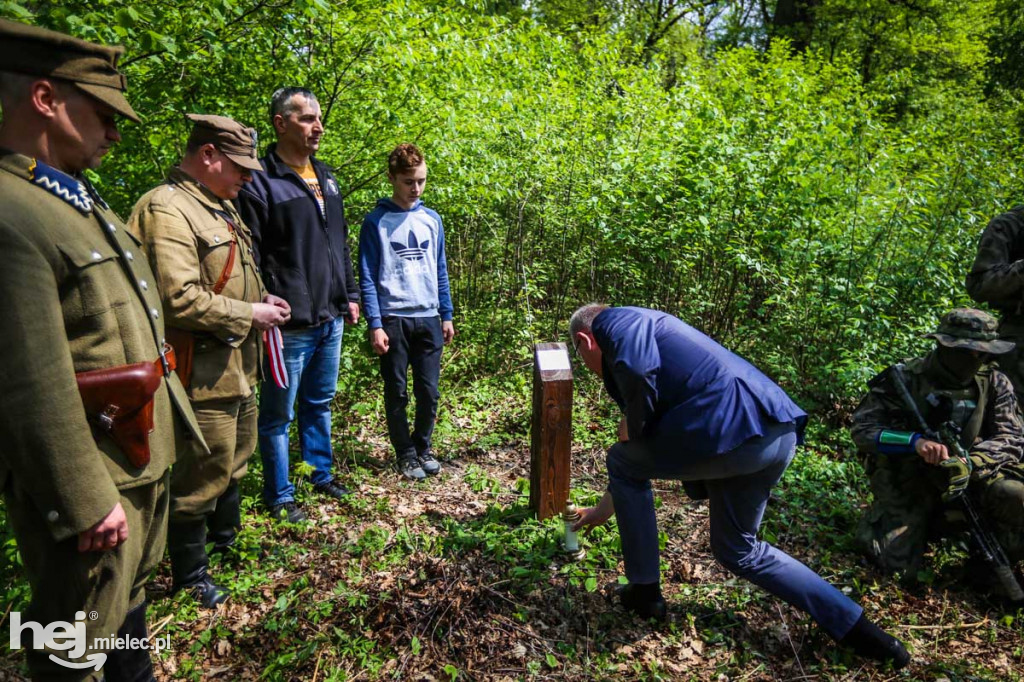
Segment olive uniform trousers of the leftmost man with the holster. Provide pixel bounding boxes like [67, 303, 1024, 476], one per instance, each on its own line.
[5, 474, 168, 682]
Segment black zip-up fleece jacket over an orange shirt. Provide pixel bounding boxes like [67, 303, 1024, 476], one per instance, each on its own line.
[236, 144, 359, 329]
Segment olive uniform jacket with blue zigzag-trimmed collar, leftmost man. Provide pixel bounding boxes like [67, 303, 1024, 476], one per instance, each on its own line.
[0, 152, 203, 542]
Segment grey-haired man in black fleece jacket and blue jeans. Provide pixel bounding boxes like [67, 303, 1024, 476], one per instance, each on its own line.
[238, 88, 359, 522]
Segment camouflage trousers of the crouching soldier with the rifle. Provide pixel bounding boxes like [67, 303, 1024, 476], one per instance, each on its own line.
[857, 455, 1024, 578]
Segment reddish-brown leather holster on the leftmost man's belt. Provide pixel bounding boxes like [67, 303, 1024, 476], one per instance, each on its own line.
[75, 346, 175, 467]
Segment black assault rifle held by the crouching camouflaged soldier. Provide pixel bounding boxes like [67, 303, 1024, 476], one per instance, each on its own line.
[889, 365, 1024, 603]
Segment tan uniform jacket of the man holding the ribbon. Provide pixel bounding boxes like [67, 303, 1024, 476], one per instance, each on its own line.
[129, 168, 266, 401]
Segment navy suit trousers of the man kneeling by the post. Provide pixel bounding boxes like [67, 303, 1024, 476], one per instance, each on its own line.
[607, 424, 863, 640]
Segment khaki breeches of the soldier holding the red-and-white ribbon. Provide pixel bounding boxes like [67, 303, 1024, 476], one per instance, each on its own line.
[171, 391, 257, 521]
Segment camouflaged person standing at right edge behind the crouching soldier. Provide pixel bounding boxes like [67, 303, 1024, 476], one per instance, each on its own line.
[967, 205, 1024, 393]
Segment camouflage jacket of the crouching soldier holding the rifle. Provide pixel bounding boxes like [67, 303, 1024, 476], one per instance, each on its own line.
[851, 350, 1024, 478]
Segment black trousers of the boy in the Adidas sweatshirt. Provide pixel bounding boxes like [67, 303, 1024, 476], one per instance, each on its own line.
[381, 316, 444, 458]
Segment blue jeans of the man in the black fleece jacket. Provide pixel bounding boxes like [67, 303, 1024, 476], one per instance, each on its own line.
[258, 317, 345, 507]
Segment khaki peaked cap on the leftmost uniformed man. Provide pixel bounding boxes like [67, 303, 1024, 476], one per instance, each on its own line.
[0, 19, 139, 123]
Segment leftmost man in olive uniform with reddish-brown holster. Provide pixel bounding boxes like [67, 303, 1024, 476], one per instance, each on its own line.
[0, 19, 202, 681]
